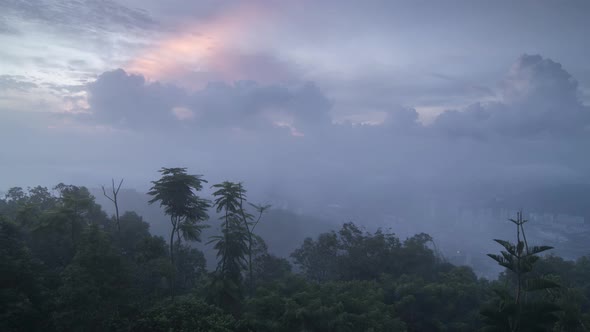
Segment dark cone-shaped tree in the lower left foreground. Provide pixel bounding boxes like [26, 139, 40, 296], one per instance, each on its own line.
[53, 224, 134, 331]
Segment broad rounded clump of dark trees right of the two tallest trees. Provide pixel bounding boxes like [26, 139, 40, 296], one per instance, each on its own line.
[291, 223, 440, 282]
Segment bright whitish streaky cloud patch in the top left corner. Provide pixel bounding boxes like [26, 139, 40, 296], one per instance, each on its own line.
[0, 0, 159, 94]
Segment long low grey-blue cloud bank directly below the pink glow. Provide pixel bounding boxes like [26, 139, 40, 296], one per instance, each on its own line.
[81, 69, 331, 133]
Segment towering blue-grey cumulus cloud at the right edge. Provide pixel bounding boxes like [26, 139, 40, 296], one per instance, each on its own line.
[433, 55, 590, 138]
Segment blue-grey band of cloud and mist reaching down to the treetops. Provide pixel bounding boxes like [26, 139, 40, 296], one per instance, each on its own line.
[2, 55, 590, 274]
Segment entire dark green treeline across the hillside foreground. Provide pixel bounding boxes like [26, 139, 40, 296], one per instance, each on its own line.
[0, 168, 590, 331]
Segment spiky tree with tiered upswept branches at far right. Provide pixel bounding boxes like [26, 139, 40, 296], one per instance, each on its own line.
[481, 212, 559, 332]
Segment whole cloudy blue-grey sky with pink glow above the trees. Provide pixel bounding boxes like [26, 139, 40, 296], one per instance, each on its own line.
[0, 0, 590, 213]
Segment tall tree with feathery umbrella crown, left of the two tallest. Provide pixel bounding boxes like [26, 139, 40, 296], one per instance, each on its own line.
[148, 167, 211, 264]
